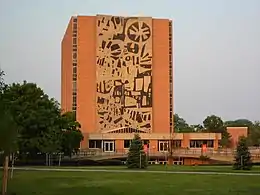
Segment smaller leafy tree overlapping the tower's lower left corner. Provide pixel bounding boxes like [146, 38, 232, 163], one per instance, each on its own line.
[60, 112, 84, 156]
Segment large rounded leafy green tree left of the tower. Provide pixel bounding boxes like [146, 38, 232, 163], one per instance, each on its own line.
[3, 82, 60, 156]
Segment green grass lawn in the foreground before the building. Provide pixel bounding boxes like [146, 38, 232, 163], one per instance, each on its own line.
[1, 166, 260, 195]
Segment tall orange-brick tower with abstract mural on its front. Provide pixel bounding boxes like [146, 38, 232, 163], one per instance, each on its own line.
[61, 15, 174, 151]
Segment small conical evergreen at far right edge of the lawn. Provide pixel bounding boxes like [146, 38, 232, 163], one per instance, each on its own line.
[233, 136, 252, 170]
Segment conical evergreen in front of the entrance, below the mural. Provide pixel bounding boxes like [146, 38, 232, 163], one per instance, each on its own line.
[126, 134, 148, 169]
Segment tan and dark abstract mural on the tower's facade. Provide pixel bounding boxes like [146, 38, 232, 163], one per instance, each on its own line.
[96, 15, 152, 132]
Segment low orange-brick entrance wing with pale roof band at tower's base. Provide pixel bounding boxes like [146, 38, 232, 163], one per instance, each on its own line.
[88, 133, 221, 154]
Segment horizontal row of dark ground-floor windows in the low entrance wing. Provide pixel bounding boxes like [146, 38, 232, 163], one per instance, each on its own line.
[89, 140, 214, 152]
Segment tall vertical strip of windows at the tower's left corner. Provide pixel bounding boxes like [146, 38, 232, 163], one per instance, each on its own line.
[72, 18, 77, 114]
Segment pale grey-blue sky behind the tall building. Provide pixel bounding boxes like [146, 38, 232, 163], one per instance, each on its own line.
[0, 0, 260, 124]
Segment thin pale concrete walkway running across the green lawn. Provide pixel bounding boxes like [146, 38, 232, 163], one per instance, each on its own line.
[11, 167, 260, 176]
